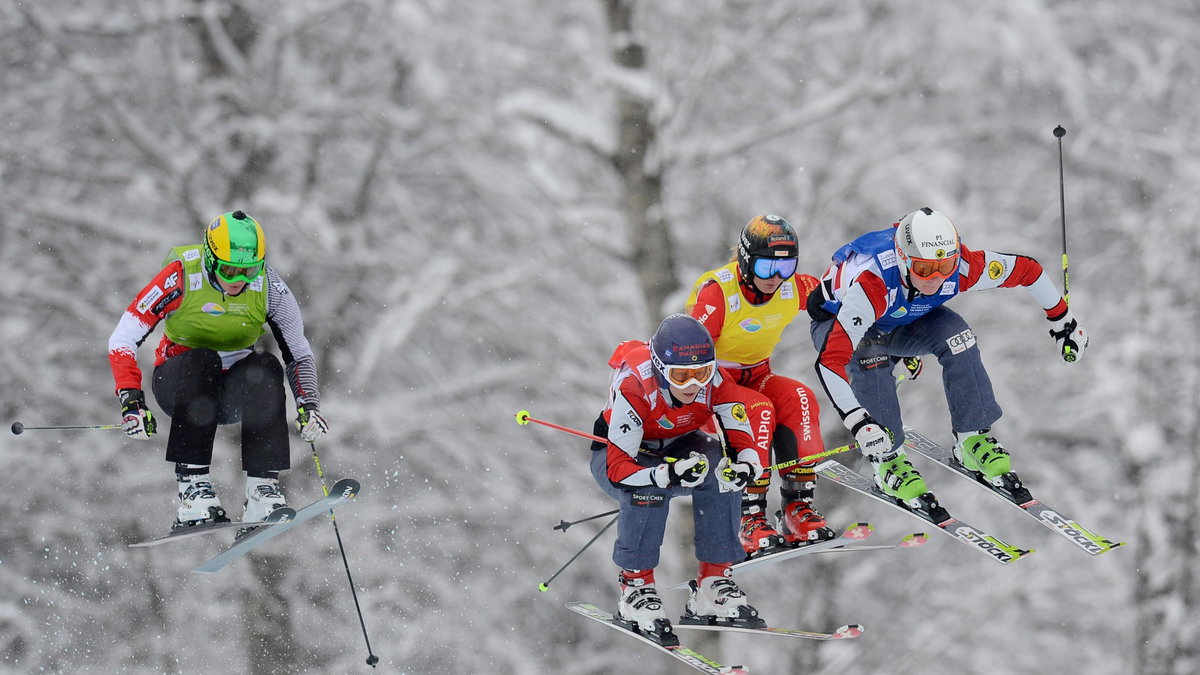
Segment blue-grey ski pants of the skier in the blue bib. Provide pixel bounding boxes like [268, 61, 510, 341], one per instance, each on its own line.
[810, 306, 1001, 448]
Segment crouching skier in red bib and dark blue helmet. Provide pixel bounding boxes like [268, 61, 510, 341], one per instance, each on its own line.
[592, 315, 766, 644]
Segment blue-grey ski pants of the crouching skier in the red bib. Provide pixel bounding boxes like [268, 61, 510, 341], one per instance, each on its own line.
[592, 431, 746, 569]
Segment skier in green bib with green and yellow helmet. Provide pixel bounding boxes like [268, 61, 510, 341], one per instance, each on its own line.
[108, 210, 328, 528]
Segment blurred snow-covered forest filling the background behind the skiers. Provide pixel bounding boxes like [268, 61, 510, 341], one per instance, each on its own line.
[0, 0, 1200, 675]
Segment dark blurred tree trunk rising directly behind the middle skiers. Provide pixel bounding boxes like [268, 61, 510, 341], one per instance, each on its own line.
[604, 0, 678, 325]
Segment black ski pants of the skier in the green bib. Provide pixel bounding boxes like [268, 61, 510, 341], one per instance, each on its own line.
[154, 348, 290, 473]
